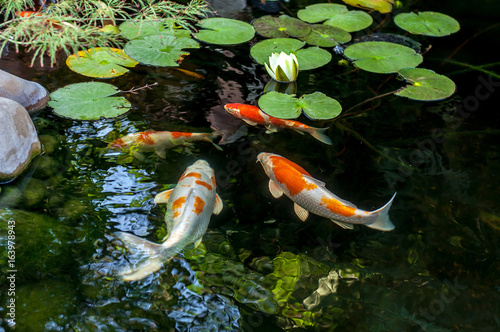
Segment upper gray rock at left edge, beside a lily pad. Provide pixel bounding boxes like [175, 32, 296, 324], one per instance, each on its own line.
[0, 70, 49, 113]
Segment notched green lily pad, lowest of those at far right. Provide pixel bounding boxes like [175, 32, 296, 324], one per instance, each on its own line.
[395, 68, 455, 101]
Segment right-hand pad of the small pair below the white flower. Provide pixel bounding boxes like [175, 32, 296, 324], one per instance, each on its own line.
[299, 92, 342, 120]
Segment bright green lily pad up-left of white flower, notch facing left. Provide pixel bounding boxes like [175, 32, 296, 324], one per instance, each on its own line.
[194, 17, 255, 45]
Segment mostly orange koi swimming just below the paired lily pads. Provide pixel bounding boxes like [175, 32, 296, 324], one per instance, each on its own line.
[224, 103, 332, 145]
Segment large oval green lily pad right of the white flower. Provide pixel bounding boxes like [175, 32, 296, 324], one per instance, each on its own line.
[344, 42, 423, 74]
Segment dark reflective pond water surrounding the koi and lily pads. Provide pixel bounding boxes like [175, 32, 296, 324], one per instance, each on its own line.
[0, 1, 500, 331]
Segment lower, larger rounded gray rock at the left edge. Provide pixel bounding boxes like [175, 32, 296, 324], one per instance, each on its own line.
[0, 97, 41, 182]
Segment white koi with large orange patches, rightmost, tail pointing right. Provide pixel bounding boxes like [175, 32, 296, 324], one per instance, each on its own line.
[257, 152, 396, 231]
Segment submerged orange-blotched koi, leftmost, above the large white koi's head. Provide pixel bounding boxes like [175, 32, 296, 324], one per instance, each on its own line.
[108, 130, 222, 160]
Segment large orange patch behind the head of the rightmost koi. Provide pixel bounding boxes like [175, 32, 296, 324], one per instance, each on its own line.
[270, 156, 318, 196]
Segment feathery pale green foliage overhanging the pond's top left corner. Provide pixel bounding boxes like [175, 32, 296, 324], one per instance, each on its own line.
[0, 0, 210, 65]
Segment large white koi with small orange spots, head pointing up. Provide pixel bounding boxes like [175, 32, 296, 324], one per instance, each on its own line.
[114, 160, 222, 281]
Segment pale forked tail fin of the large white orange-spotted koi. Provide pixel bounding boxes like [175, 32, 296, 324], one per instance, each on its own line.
[114, 232, 175, 281]
